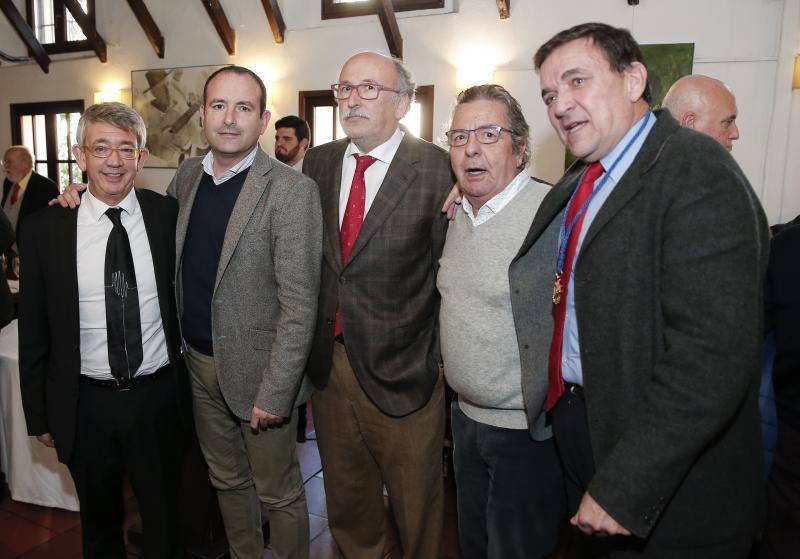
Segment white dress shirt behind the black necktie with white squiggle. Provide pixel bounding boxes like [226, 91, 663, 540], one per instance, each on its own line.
[77, 190, 169, 380]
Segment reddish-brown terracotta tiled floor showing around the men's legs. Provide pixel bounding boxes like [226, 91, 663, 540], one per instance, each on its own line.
[0, 410, 461, 559]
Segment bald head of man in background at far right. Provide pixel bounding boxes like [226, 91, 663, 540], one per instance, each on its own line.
[663, 74, 739, 151]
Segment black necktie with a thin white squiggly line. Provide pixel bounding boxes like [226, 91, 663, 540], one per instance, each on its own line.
[104, 208, 142, 379]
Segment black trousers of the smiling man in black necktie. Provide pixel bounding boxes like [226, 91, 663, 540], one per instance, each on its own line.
[68, 371, 181, 559]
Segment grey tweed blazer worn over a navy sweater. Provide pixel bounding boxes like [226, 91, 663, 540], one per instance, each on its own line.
[167, 148, 322, 420]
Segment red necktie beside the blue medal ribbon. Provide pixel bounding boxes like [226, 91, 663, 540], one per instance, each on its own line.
[544, 161, 603, 410]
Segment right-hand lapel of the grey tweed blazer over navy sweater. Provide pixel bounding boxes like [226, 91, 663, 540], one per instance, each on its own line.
[214, 148, 272, 291]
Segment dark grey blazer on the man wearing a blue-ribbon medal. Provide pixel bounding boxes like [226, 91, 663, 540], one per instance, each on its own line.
[519, 111, 768, 557]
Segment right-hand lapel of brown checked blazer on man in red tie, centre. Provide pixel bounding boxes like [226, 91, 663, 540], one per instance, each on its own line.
[345, 132, 419, 267]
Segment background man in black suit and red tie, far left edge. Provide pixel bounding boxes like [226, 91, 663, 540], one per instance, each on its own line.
[3, 146, 58, 233]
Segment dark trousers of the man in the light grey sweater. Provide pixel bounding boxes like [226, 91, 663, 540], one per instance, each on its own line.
[452, 401, 565, 559]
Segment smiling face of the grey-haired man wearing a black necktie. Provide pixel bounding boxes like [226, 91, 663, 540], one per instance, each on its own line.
[72, 122, 147, 206]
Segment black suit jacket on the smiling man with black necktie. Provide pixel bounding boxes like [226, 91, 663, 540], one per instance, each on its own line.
[19, 190, 191, 463]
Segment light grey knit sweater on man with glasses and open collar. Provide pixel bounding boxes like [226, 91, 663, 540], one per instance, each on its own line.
[437, 180, 555, 429]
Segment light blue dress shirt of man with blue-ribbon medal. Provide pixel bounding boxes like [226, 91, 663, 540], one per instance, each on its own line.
[561, 111, 656, 386]
